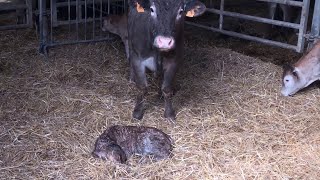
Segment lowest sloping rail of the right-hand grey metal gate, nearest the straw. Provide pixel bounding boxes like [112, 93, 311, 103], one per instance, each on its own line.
[186, 22, 297, 51]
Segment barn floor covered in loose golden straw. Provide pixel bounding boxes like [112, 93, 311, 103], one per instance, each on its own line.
[0, 30, 320, 179]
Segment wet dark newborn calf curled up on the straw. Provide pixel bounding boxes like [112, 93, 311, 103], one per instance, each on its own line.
[92, 126, 173, 163]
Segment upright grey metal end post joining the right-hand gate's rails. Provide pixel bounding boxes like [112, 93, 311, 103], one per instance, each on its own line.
[297, 0, 310, 53]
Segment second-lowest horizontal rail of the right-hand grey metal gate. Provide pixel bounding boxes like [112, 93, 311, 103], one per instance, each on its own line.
[207, 8, 300, 29]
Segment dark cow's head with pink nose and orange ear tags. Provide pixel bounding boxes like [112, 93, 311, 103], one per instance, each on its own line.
[130, 0, 206, 51]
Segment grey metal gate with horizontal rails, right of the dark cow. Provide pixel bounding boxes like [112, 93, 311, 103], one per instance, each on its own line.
[187, 0, 320, 52]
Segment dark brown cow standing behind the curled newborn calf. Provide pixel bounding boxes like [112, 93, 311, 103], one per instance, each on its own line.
[128, 0, 206, 120]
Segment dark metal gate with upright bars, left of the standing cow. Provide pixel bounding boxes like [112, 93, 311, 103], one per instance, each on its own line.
[39, 0, 126, 55]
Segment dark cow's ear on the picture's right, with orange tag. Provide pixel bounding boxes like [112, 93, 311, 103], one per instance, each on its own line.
[184, 0, 206, 17]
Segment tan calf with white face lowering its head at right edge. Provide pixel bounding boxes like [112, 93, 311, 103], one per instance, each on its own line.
[281, 40, 320, 96]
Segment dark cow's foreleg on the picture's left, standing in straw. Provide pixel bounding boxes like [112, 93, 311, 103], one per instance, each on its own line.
[131, 60, 147, 120]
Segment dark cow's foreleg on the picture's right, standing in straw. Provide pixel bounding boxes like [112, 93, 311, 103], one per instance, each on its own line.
[161, 62, 177, 120]
